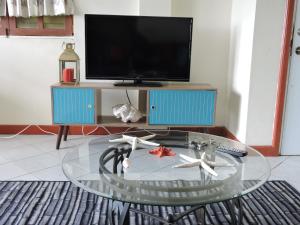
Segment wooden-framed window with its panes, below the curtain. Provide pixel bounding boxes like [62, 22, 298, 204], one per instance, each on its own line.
[0, 16, 73, 36]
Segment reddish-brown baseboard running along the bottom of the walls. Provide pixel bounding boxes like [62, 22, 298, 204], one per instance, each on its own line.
[0, 125, 279, 156]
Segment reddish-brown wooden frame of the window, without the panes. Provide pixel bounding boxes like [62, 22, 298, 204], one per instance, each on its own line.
[0, 16, 73, 36]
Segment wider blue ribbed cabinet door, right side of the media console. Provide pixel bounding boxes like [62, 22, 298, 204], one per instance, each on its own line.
[149, 90, 216, 126]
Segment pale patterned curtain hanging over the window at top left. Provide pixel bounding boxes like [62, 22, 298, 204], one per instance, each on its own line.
[0, 0, 74, 17]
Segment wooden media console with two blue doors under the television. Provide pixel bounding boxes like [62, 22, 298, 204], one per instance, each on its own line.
[51, 82, 217, 149]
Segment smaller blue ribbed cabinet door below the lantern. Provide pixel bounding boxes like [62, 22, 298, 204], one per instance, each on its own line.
[52, 88, 95, 124]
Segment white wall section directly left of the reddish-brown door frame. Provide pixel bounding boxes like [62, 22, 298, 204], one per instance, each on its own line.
[246, 0, 285, 145]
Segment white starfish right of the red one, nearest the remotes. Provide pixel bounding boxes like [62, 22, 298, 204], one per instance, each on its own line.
[173, 152, 234, 176]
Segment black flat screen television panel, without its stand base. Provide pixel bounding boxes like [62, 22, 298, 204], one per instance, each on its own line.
[85, 15, 193, 84]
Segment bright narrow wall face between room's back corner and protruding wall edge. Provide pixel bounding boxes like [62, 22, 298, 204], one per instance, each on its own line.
[226, 0, 256, 142]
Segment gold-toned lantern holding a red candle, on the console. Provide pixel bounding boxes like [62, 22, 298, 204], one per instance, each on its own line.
[59, 43, 80, 84]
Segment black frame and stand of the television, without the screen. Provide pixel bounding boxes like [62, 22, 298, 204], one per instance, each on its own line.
[84, 14, 193, 87]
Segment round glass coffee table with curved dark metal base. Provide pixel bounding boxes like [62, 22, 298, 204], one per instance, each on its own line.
[62, 130, 270, 224]
